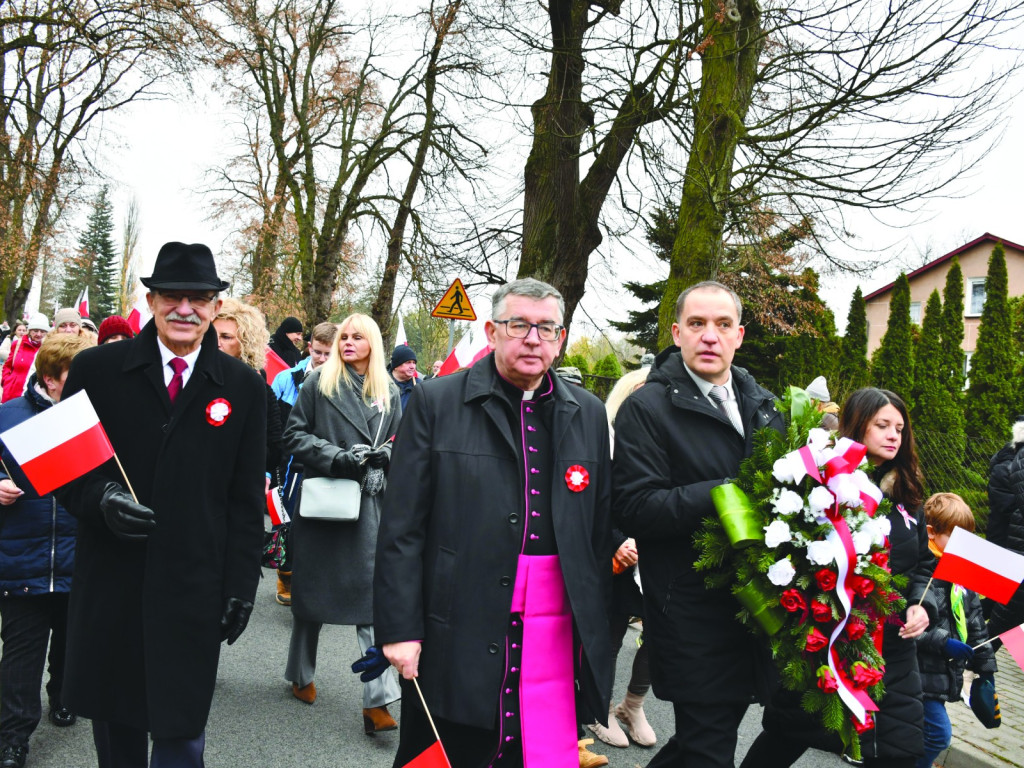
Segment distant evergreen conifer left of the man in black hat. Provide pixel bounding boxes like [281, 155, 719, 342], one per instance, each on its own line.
[60, 186, 121, 326]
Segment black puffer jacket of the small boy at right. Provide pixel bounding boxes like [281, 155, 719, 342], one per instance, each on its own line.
[918, 581, 995, 701]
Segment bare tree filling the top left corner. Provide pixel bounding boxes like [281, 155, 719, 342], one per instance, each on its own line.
[0, 0, 199, 315]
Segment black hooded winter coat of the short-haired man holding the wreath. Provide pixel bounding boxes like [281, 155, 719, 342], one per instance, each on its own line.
[612, 347, 784, 702]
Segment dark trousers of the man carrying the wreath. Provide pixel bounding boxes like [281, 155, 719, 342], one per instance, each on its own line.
[647, 701, 749, 768]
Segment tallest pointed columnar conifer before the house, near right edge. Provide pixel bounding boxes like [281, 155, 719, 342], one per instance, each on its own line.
[966, 243, 1017, 448]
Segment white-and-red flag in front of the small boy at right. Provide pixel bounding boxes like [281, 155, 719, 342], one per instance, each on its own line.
[935, 527, 1024, 605]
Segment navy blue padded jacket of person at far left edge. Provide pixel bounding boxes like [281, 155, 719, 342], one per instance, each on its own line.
[0, 375, 78, 597]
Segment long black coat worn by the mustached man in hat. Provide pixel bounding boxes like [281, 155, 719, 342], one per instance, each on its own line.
[57, 321, 266, 738]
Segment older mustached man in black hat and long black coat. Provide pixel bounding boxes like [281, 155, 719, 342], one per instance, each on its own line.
[58, 243, 266, 768]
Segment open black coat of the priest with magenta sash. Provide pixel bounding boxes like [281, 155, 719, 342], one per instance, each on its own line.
[374, 355, 614, 728]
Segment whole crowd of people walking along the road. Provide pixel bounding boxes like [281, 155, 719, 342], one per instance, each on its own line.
[0, 243, 1024, 768]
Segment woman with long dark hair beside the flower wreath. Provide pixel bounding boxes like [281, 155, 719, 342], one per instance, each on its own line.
[741, 387, 935, 768]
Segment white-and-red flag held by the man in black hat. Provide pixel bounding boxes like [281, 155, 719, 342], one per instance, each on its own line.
[0, 390, 114, 496]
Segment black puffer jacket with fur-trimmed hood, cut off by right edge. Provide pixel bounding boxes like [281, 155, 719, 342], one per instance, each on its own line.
[988, 422, 1024, 637]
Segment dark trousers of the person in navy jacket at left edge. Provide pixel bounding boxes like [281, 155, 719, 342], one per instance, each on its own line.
[0, 592, 68, 746]
